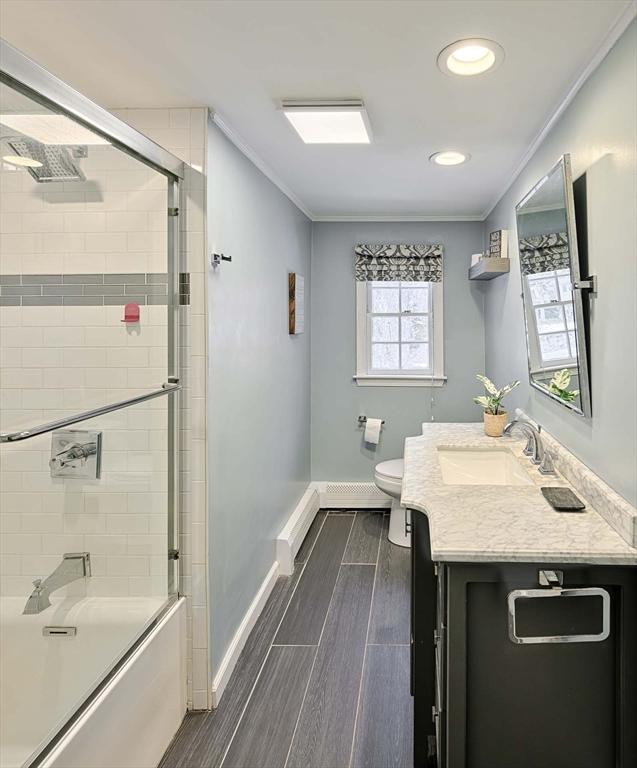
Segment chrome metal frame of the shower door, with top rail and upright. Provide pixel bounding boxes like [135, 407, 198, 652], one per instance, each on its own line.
[0, 38, 185, 768]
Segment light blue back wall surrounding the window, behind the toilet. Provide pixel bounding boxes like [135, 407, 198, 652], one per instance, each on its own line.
[312, 222, 484, 481]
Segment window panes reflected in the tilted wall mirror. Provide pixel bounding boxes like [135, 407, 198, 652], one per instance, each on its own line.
[526, 268, 577, 369]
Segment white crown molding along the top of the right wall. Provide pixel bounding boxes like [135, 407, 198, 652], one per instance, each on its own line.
[481, 0, 637, 221]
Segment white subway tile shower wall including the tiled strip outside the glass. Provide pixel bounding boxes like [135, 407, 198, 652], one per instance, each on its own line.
[0, 109, 209, 708]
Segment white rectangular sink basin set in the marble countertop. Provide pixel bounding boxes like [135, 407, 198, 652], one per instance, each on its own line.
[438, 446, 533, 485]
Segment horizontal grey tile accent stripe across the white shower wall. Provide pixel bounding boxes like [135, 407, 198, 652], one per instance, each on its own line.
[0, 272, 168, 307]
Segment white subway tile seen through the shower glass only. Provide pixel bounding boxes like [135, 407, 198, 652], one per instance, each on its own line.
[0, 141, 168, 598]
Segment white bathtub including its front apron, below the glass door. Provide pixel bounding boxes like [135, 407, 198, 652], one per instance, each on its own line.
[0, 597, 186, 768]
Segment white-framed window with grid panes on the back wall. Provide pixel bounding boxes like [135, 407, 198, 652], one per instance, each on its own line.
[356, 280, 444, 386]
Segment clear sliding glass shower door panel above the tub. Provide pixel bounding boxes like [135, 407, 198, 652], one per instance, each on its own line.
[0, 61, 181, 768]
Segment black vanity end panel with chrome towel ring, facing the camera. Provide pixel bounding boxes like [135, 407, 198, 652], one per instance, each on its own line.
[447, 565, 637, 768]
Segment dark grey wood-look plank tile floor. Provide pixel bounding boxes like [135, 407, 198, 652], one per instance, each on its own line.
[160, 510, 413, 768]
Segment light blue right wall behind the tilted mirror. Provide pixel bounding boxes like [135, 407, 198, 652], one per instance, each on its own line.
[485, 22, 637, 504]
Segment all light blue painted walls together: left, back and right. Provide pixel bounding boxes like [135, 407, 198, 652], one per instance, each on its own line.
[208, 23, 637, 674]
